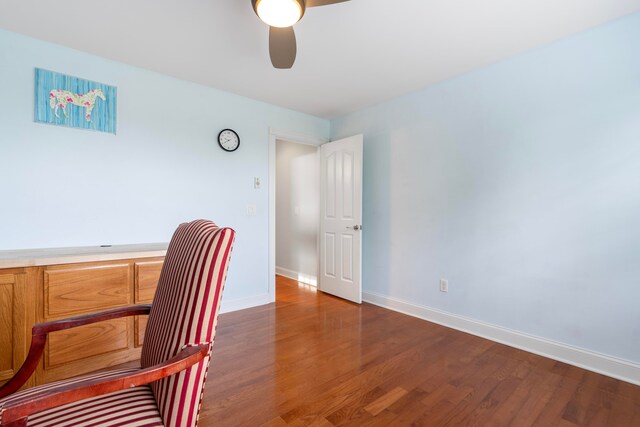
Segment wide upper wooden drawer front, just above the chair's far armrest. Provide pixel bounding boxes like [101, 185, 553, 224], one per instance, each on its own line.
[44, 264, 131, 320]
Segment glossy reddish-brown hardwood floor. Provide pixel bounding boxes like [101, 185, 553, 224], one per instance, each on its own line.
[200, 277, 640, 427]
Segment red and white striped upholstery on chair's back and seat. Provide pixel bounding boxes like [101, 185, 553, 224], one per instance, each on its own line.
[0, 220, 235, 427]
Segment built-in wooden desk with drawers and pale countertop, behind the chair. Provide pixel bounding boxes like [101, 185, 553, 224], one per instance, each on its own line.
[0, 243, 167, 386]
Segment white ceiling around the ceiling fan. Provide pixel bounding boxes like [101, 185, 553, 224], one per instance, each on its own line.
[0, 0, 640, 118]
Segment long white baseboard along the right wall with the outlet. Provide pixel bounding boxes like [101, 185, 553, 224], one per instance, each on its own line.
[362, 292, 640, 385]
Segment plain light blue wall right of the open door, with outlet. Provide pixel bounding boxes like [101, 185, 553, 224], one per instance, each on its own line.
[331, 14, 640, 363]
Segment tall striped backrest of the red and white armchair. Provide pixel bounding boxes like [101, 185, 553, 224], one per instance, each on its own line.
[141, 220, 235, 427]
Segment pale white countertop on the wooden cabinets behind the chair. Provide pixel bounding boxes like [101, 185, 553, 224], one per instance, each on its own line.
[0, 243, 169, 268]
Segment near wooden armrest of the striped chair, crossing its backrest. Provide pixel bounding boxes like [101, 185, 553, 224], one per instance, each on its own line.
[2, 343, 211, 427]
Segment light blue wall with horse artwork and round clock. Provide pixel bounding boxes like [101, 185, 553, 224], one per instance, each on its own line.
[0, 30, 329, 308]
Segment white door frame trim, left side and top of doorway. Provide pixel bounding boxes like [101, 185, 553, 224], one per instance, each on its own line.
[268, 128, 329, 302]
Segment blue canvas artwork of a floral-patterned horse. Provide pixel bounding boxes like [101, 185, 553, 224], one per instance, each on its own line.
[35, 68, 118, 134]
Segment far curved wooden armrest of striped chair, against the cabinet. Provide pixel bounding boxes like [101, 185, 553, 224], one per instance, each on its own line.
[0, 304, 151, 398]
